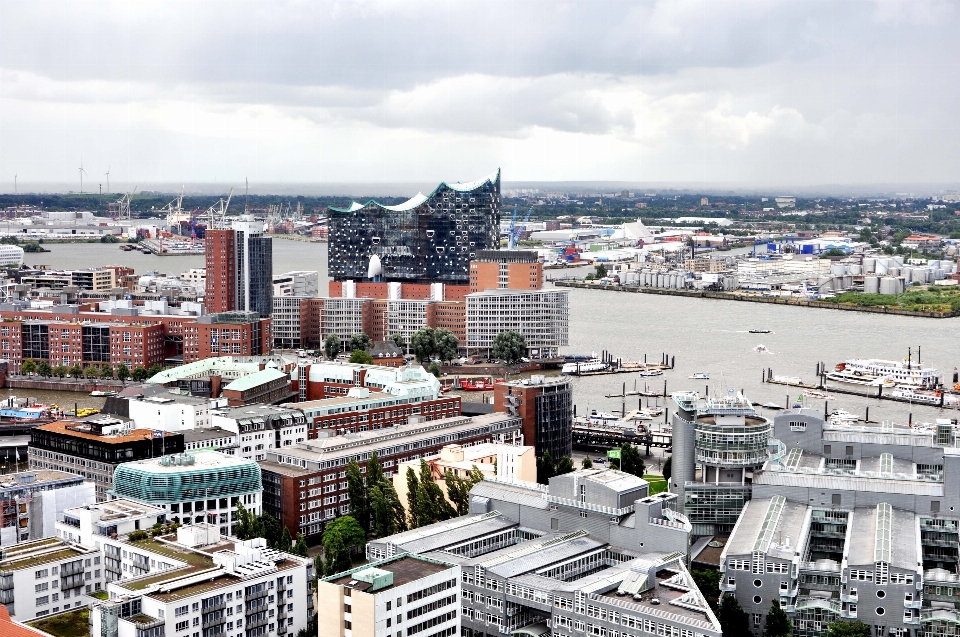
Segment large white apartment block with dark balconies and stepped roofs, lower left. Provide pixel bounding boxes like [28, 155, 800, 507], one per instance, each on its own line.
[79, 524, 313, 637]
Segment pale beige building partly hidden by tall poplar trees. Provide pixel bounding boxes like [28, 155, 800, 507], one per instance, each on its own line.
[393, 442, 537, 513]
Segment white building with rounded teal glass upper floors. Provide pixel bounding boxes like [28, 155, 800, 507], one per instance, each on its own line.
[107, 451, 263, 535]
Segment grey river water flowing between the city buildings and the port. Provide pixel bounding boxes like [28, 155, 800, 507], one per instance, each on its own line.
[30, 239, 960, 422]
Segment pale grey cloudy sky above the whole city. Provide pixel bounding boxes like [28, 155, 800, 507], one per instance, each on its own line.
[0, 0, 960, 191]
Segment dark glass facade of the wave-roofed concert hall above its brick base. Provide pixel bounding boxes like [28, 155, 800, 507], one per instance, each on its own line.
[328, 171, 500, 284]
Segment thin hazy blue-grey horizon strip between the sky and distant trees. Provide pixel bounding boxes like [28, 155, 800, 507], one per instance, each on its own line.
[0, 180, 960, 199]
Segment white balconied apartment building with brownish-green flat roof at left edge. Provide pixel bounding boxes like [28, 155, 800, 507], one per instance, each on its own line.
[0, 537, 103, 622]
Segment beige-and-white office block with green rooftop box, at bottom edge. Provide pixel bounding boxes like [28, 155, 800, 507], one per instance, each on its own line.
[317, 554, 460, 637]
